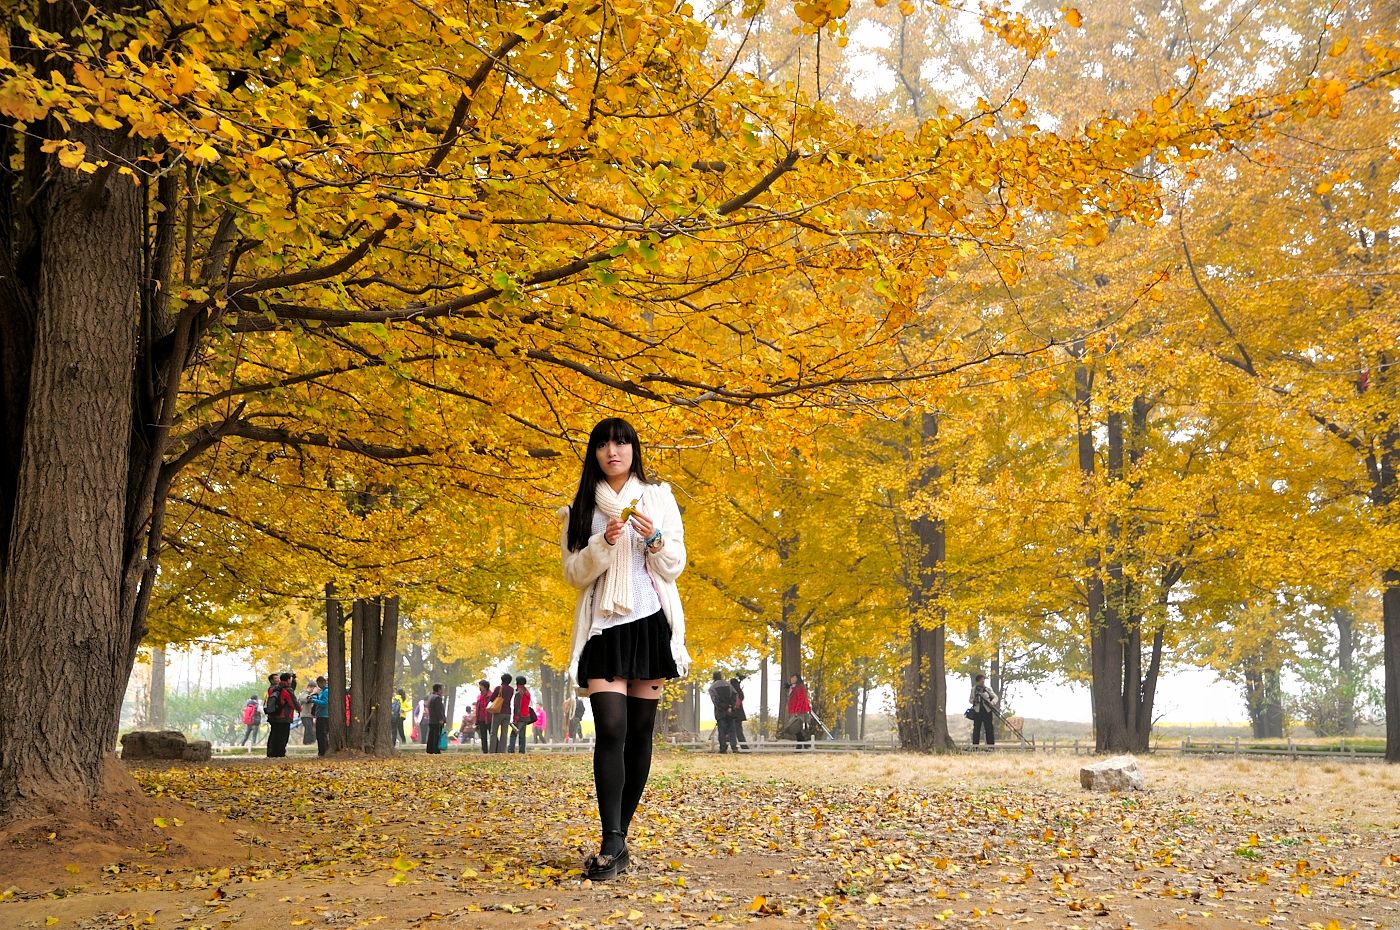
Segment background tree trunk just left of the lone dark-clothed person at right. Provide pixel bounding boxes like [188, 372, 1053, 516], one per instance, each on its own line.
[896, 413, 955, 752]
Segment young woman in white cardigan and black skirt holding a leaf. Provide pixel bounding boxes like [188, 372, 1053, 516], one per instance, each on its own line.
[560, 417, 690, 881]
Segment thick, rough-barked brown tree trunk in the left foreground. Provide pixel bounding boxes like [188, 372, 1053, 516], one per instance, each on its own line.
[0, 95, 146, 818]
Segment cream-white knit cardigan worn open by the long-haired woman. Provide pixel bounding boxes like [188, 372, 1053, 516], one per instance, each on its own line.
[559, 483, 690, 685]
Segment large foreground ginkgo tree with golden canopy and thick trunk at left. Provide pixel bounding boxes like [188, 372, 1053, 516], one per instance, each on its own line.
[0, 0, 1394, 817]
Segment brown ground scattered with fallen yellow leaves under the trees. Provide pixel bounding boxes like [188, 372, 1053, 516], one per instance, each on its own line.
[0, 754, 1400, 930]
